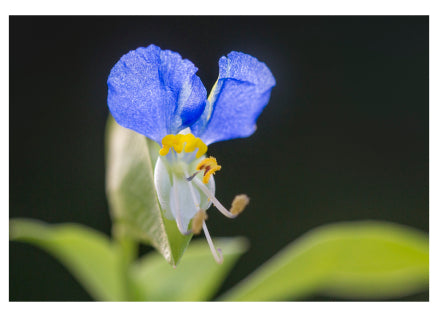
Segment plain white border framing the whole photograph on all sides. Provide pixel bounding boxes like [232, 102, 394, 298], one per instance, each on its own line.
[0, 0, 439, 316]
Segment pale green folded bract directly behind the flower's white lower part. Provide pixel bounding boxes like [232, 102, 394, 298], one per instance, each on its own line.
[106, 116, 192, 266]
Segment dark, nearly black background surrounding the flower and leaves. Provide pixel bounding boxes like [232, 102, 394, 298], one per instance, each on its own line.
[9, 16, 429, 301]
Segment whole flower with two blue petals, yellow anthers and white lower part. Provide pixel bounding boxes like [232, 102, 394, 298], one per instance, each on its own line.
[108, 45, 276, 262]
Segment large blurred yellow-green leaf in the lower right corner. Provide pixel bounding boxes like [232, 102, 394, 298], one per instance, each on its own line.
[221, 221, 429, 301]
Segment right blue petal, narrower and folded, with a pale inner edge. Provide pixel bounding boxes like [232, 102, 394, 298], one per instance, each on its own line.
[191, 52, 276, 144]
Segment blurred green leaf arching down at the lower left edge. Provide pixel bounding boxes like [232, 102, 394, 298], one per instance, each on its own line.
[9, 219, 125, 301]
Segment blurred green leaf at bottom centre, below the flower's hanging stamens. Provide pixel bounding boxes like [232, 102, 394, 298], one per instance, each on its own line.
[132, 238, 247, 301]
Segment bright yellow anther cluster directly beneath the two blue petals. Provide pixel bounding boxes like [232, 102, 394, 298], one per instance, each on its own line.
[159, 134, 207, 158]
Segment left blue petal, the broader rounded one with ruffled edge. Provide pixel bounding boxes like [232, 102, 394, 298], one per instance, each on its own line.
[107, 45, 206, 143]
